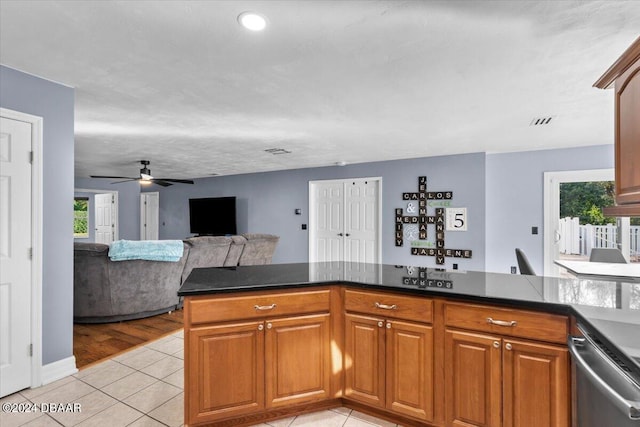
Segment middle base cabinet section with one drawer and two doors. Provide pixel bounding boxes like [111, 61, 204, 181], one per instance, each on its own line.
[344, 290, 434, 421]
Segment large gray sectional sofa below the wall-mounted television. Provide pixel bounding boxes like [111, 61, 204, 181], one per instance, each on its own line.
[73, 233, 279, 323]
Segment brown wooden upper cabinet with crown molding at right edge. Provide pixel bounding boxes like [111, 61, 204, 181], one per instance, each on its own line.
[594, 37, 640, 216]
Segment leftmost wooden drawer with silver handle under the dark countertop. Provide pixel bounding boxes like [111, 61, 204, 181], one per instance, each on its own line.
[187, 289, 330, 325]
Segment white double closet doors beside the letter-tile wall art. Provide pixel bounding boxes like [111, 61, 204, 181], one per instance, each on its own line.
[309, 178, 381, 263]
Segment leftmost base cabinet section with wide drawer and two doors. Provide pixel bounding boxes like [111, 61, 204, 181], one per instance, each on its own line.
[185, 290, 332, 425]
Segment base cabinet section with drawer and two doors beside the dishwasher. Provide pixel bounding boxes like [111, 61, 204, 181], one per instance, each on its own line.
[445, 304, 570, 427]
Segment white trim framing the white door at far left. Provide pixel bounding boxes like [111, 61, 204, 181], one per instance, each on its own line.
[0, 108, 43, 388]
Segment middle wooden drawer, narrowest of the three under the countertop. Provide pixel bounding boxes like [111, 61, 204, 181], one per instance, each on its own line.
[344, 289, 433, 323]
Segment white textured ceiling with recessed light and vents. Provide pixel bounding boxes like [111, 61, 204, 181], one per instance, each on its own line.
[0, 0, 640, 178]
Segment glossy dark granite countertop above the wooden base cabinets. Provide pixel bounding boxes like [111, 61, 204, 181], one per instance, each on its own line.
[178, 262, 640, 375]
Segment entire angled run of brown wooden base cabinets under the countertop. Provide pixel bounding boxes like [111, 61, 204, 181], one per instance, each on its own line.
[185, 285, 570, 427]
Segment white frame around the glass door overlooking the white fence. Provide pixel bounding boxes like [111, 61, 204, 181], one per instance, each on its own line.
[543, 168, 614, 276]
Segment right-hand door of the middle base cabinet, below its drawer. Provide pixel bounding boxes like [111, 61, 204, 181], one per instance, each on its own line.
[385, 320, 433, 421]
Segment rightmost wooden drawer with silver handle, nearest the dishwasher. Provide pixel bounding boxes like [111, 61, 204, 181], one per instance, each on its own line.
[444, 303, 569, 344]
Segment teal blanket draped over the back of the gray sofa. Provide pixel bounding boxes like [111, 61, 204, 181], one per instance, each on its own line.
[109, 240, 184, 262]
